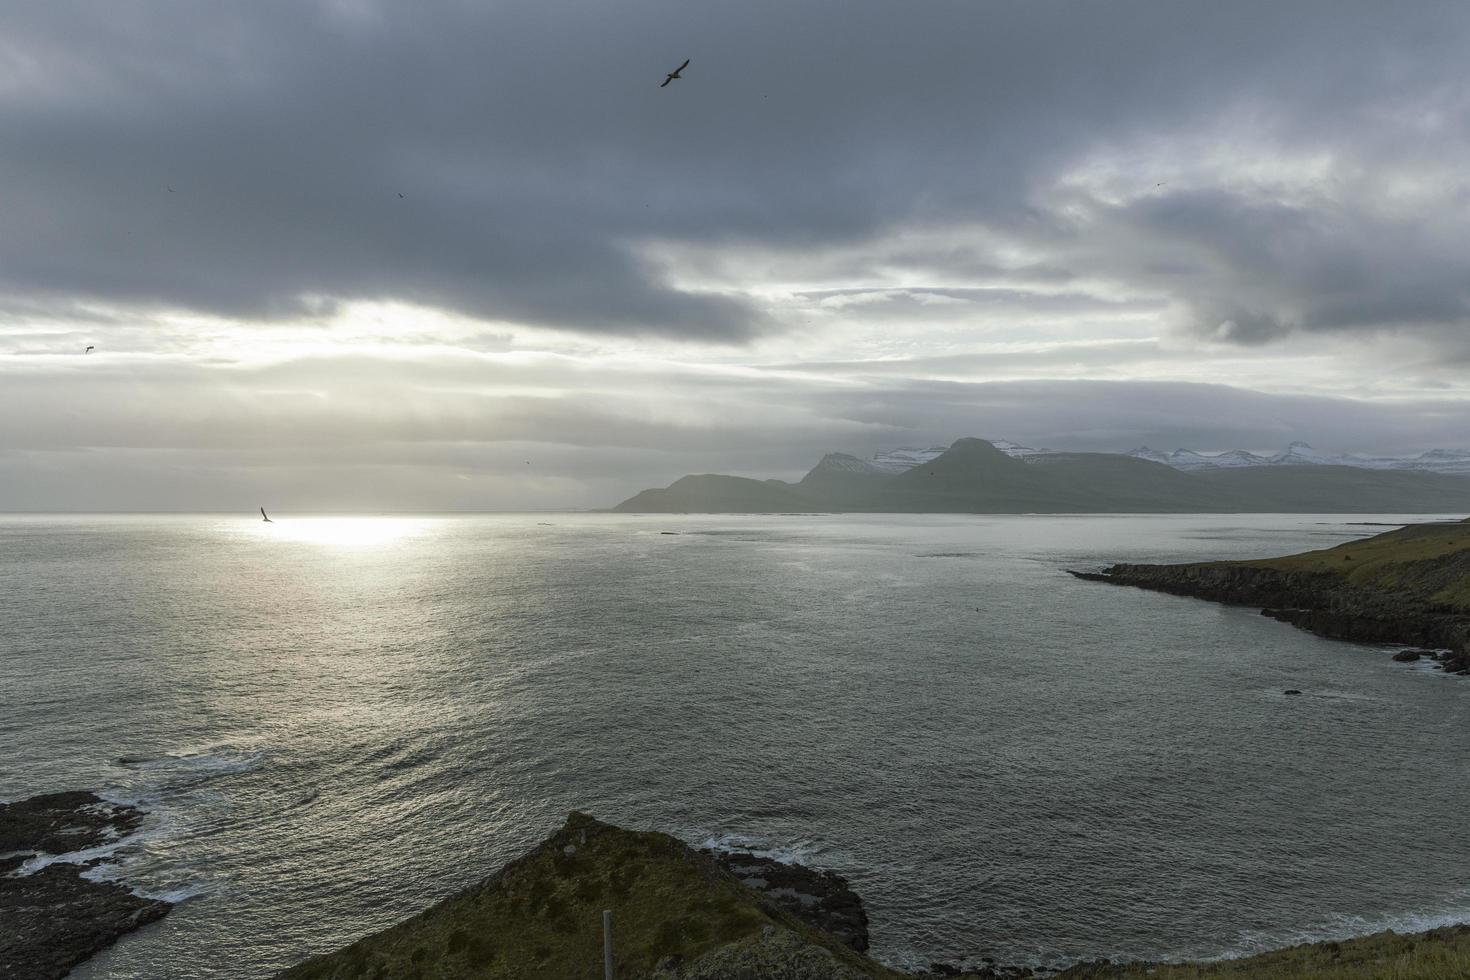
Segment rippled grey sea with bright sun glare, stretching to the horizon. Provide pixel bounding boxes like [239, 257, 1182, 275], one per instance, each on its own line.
[0, 514, 1470, 979]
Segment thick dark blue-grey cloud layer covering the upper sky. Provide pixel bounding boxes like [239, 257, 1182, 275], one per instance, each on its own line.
[0, 0, 1470, 342]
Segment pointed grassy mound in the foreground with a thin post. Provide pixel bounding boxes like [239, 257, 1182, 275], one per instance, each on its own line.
[281, 814, 898, 980]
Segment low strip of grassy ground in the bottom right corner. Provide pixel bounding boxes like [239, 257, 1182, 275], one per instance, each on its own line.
[1058, 926, 1470, 980]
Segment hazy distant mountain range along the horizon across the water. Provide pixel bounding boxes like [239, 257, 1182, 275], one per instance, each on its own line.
[614, 439, 1470, 514]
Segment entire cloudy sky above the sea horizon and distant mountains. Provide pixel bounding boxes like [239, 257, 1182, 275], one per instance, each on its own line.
[0, 0, 1470, 511]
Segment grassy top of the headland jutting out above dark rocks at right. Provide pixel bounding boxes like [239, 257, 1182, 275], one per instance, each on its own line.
[1222, 520, 1470, 611]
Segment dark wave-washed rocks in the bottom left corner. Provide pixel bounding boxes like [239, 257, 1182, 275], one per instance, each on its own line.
[0, 792, 172, 980]
